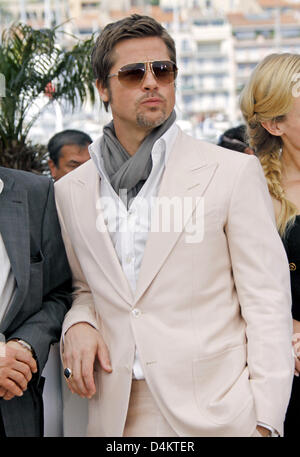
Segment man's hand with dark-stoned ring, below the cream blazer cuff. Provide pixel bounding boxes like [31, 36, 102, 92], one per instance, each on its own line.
[63, 322, 112, 398]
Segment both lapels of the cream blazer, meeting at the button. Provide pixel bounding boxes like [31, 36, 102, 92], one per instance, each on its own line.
[70, 133, 218, 306]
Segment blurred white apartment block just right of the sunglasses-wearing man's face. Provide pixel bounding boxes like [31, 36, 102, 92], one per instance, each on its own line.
[173, 17, 235, 126]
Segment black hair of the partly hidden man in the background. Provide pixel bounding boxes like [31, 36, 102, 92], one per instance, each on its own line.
[48, 130, 93, 167]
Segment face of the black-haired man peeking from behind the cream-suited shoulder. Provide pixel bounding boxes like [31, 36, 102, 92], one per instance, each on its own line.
[48, 144, 90, 181]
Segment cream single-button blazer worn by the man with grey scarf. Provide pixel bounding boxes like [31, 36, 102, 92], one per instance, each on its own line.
[55, 126, 294, 437]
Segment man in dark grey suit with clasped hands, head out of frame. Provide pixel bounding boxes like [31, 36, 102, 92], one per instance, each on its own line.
[0, 167, 71, 437]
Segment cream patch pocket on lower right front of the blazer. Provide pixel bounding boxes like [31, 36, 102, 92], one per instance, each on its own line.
[193, 345, 253, 425]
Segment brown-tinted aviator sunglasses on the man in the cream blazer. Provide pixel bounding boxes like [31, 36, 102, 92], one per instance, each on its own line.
[108, 60, 178, 89]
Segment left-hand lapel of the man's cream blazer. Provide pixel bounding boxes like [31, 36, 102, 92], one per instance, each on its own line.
[71, 165, 133, 305]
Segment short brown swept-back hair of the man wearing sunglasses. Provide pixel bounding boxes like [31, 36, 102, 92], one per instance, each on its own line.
[92, 14, 176, 111]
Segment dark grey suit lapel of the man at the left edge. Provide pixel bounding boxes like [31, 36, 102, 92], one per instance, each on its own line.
[0, 171, 30, 330]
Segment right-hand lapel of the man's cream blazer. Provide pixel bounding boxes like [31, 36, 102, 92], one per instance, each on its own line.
[135, 129, 218, 303]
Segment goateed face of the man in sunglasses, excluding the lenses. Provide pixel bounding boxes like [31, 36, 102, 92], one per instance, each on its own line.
[97, 37, 175, 134]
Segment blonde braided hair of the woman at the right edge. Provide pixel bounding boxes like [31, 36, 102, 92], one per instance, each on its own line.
[240, 53, 300, 237]
